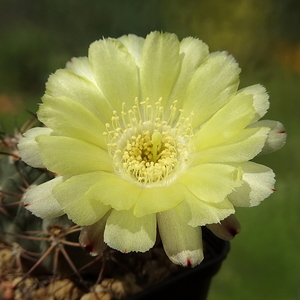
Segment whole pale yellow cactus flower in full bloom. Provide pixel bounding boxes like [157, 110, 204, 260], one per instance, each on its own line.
[19, 32, 285, 266]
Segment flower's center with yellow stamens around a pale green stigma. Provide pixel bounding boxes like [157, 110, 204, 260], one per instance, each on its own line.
[104, 99, 192, 188]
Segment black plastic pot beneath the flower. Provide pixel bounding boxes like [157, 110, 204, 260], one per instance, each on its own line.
[130, 228, 230, 300]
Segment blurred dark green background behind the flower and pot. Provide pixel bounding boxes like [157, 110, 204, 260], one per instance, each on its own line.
[0, 0, 300, 300]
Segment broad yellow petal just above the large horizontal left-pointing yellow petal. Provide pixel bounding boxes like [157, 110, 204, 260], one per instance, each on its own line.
[38, 95, 107, 149]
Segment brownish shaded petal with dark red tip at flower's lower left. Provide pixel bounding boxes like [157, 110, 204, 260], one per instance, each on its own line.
[79, 212, 110, 256]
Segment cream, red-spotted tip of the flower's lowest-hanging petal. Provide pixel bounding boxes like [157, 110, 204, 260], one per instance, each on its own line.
[169, 249, 204, 268]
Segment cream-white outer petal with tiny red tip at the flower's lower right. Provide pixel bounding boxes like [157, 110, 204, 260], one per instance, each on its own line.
[228, 162, 275, 206]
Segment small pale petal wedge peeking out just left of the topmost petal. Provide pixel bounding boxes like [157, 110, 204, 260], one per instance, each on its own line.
[118, 34, 145, 67]
